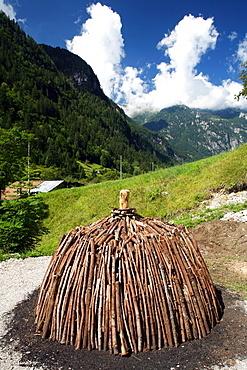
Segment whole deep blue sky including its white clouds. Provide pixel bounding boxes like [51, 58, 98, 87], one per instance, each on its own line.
[0, 0, 247, 115]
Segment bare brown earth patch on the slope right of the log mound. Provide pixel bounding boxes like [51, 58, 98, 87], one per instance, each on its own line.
[191, 220, 247, 298]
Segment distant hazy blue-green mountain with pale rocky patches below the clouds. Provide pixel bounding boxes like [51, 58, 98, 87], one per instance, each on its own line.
[133, 105, 247, 160]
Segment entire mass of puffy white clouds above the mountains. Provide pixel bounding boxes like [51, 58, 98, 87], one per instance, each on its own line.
[66, 3, 247, 115]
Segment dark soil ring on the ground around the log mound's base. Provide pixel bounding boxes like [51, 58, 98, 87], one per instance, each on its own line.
[0, 288, 247, 370]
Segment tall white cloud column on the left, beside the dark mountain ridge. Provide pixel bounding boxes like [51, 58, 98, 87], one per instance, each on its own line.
[66, 3, 124, 96]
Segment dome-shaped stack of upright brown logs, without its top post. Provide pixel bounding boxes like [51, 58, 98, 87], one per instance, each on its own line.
[35, 208, 221, 355]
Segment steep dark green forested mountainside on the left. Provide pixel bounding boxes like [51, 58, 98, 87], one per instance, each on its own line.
[0, 13, 175, 183]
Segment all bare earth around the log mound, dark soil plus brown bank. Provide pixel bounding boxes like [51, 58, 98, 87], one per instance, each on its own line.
[1, 220, 247, 370]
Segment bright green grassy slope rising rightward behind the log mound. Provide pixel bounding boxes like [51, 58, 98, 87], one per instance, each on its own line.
[34, 144, 247, 254]
